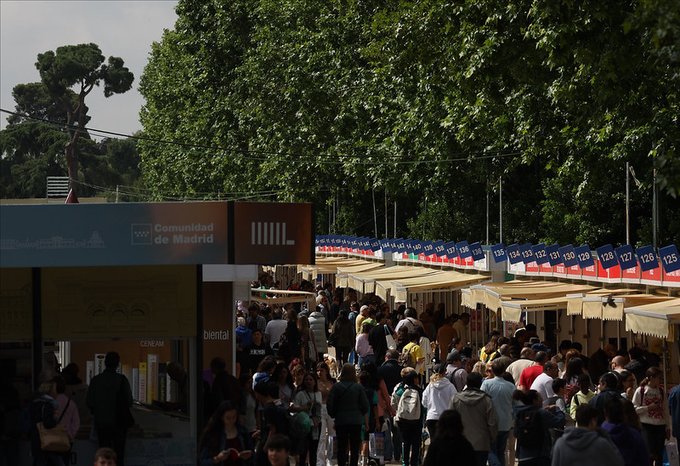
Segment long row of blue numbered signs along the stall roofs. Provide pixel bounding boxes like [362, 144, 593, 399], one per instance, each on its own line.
[315, 235, 680, 273]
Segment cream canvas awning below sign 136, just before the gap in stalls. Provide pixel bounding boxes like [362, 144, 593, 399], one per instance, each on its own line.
[376, 271, 489, 302]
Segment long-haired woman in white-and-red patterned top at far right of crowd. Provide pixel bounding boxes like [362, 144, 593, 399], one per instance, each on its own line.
[633, 367, 671, 466]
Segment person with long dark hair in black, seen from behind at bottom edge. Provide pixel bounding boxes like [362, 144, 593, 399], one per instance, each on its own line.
[423, 409, 477, 466]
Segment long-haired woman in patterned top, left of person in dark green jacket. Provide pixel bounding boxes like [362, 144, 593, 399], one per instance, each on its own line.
[290, 372, 321, 466]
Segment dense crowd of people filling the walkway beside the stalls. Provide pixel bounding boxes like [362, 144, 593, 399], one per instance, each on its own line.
[220, 278, 680, 466]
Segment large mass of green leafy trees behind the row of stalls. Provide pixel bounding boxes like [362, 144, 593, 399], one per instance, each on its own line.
[140, 0, 680, 244]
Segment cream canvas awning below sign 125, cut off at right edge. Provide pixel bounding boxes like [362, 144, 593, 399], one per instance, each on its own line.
[624, 298, 680, 339]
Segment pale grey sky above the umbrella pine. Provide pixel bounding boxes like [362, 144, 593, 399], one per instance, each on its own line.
[0, 0, 177, 134]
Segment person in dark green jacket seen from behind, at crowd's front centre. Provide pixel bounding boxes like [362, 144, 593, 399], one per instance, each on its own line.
[328, 364, 369, 466]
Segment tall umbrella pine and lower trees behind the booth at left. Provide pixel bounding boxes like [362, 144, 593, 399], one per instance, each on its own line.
[0, 44, 139, 202]
